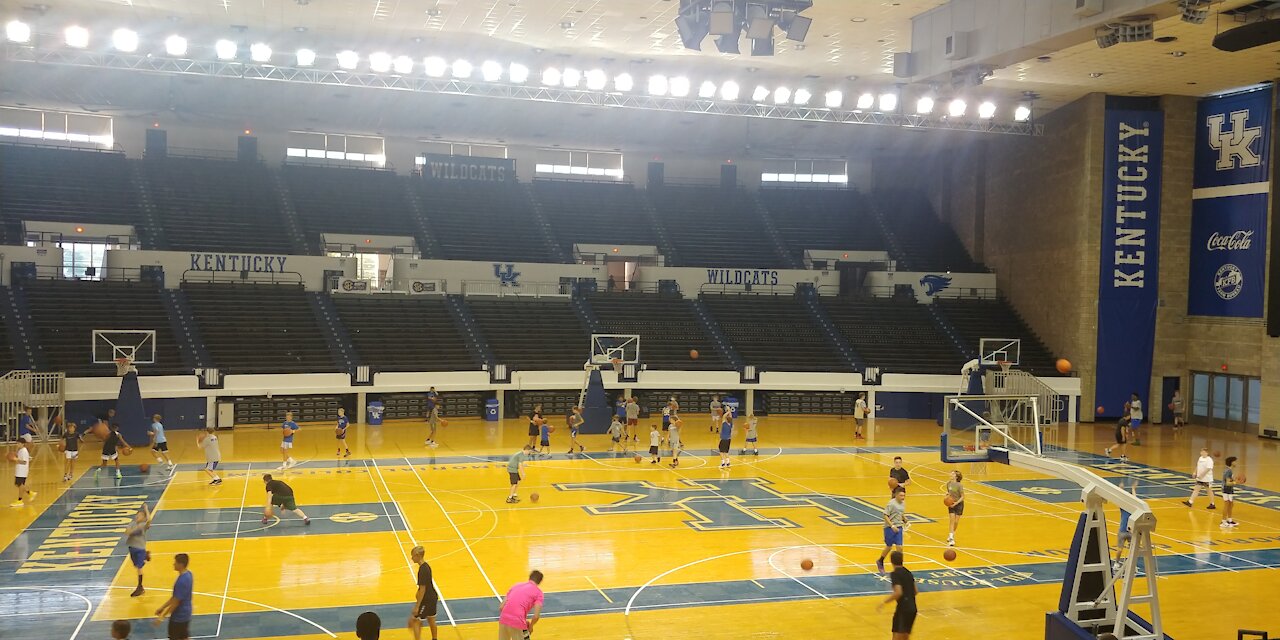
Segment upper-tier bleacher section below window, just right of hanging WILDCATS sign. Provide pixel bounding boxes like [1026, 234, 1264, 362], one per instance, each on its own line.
[534, 180, 658, 255]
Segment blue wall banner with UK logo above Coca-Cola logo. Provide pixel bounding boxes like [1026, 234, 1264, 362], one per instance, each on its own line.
[1187, 87, 1271, 317]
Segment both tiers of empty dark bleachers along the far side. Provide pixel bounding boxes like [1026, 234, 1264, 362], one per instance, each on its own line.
[0, 145, 1053, 375]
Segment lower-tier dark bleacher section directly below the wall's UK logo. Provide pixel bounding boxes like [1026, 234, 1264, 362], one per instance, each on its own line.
[466, 297, 591, 371]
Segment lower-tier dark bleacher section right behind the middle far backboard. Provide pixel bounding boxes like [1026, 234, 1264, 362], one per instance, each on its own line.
[590, 292, 731, 371]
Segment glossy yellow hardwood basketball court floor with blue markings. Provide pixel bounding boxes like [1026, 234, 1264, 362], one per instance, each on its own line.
[0, 417, 1280, 640]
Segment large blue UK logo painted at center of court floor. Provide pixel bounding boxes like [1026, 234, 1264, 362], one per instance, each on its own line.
[554, 477, 932, 531]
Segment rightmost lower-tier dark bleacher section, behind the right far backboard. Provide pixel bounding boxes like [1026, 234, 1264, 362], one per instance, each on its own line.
[933, 298, 1059, 376]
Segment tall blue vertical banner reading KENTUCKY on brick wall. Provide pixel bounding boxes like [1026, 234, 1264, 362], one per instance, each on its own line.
[1093, 109, 1165, 416]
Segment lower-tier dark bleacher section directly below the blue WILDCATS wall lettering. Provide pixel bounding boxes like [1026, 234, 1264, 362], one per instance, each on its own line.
[701, 294, 851, 371]
